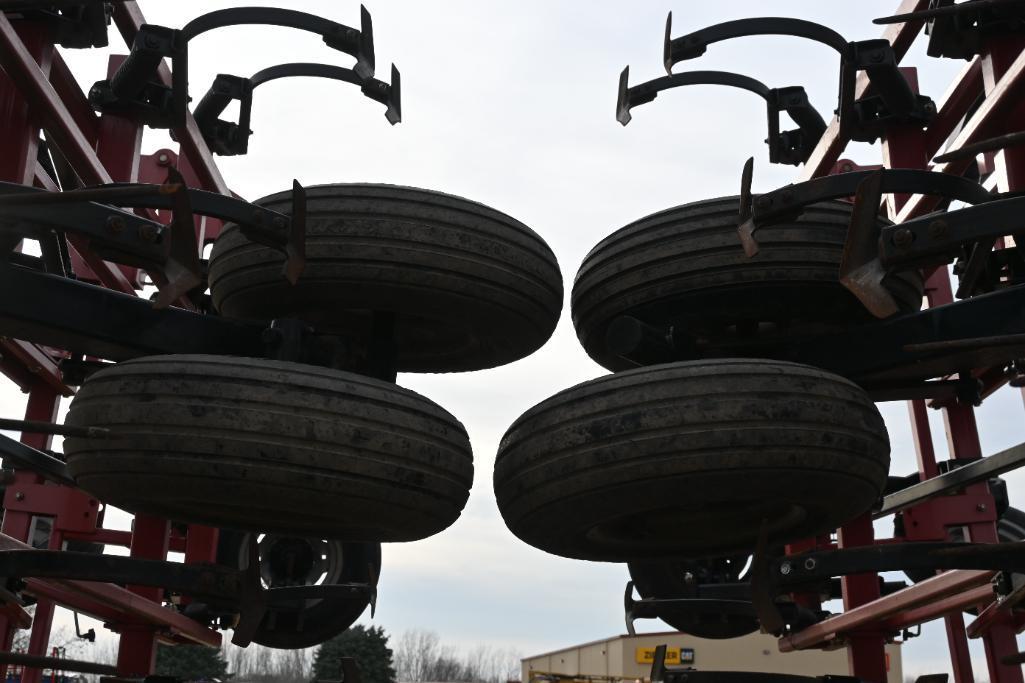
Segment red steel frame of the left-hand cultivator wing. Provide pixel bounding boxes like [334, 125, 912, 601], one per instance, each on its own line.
[0, 2, 231, 683]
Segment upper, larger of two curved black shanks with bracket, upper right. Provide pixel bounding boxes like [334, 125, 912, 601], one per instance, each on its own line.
[662, 12, 936, 142]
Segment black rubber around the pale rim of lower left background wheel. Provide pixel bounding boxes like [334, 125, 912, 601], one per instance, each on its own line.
[217, 529, 381, 649]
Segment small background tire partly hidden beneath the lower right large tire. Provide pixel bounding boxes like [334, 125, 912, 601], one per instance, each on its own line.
[627, 557, 759, 640]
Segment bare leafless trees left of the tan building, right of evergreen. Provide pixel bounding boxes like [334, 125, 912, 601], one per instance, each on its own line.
[393, 629, 520, 683]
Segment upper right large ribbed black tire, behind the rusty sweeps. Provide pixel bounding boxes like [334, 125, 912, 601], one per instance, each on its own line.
[572, 197, 924, 370]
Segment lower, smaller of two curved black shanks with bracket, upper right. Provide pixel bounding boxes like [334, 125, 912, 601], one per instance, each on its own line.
[616, 67, 826, 166]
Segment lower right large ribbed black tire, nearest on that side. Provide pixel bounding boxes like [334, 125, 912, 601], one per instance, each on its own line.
[494, 359, 890, 562]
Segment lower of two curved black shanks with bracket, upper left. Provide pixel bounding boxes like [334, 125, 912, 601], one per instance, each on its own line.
[193, 63, 402, 156]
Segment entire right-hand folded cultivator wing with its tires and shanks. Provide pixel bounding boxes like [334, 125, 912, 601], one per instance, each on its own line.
[494, 0, 1025, 683]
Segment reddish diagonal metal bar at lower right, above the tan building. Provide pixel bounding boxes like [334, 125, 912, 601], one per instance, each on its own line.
[779, 569, 994, 652]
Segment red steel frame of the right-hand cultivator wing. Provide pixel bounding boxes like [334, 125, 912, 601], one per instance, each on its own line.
[780, 0, 1025, 683]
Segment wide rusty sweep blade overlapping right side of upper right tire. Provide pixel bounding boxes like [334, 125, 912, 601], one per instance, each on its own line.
[839, 171, 899, 318]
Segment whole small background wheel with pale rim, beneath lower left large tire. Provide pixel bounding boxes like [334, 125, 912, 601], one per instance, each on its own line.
[217, 529, 381, 650]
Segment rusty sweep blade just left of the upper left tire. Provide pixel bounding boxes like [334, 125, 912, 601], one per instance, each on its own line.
[155, 167, 203, 309]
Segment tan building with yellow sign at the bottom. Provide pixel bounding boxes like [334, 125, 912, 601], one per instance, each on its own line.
[521, 632, 902, 683]
